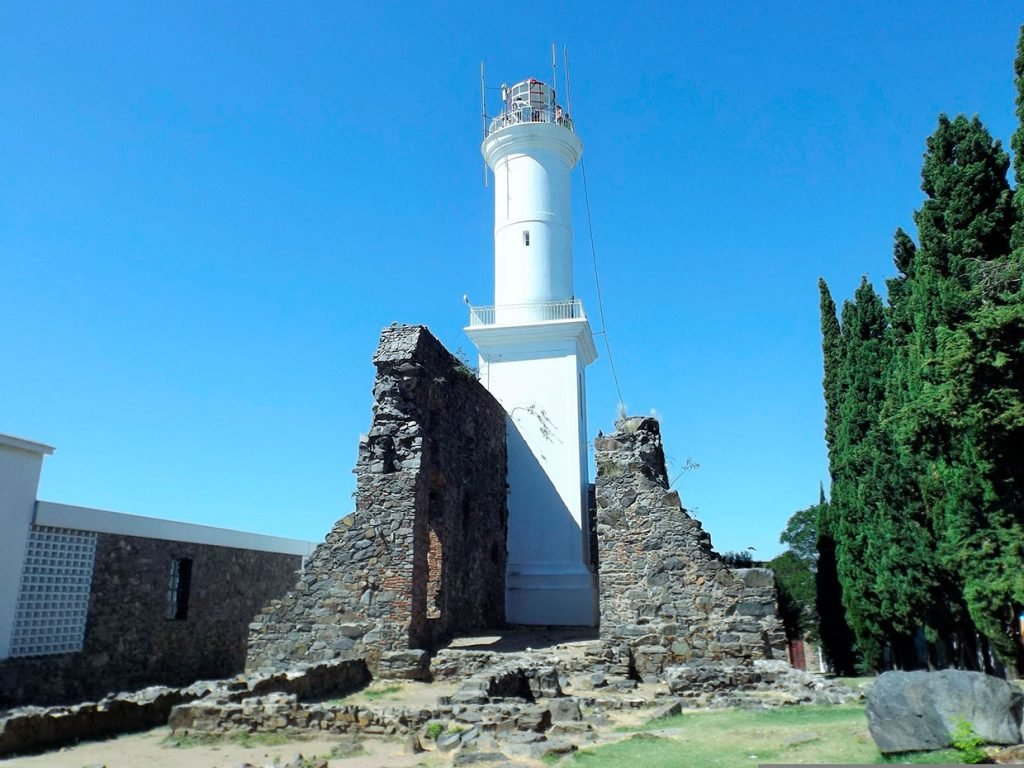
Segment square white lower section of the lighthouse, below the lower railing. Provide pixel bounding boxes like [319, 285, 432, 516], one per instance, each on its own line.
[466, 317, 598, 627]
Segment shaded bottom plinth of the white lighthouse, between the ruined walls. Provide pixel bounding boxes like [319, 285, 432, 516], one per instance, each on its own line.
[505, 564, 598, 627]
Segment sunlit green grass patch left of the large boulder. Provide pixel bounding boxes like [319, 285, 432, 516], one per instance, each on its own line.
[559, 705, 961, 768]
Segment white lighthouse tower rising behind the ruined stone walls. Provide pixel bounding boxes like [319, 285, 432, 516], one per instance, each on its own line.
[466, 80, 598, 627]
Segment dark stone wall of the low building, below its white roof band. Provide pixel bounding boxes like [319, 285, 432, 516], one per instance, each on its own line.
[0, 534, 302, 708]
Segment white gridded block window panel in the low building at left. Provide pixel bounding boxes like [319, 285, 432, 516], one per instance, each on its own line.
[10, 525, 96, 656]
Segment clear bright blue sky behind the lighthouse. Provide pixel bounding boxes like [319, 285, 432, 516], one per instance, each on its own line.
[0, 0, 1024, 557]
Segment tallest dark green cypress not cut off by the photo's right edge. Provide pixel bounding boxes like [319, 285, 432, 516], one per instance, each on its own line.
[890, 116, 1015, 666]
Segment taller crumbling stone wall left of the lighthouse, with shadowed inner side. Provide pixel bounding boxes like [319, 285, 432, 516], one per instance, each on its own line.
[247, 326, 508, 676]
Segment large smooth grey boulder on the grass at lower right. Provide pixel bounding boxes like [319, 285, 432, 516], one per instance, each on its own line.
[867, 670, 1024, 754]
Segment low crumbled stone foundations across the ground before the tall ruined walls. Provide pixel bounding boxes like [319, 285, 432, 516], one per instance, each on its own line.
[0, 641, 861, 759]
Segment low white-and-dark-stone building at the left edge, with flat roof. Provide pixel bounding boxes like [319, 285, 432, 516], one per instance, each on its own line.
[0, 435, 312, 708]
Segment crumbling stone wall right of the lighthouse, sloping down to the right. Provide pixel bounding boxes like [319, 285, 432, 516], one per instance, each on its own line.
[594, 418, 785, 676]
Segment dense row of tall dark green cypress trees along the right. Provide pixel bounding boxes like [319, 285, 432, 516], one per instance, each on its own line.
[818, 33, 1024, 672]
